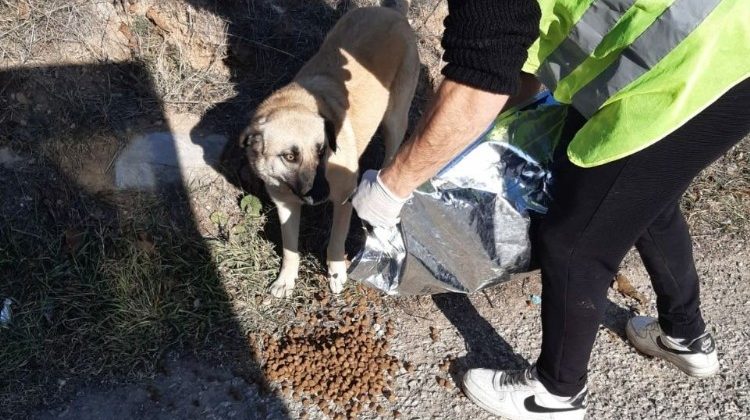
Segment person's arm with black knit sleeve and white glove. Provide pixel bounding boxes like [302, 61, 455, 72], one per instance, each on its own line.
[352, 0, 541, 226]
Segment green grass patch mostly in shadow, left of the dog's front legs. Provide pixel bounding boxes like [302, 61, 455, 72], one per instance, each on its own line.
[0, 186, 287, 411]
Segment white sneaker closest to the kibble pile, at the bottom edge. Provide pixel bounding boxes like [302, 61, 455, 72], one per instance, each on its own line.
[463, 366, 587, 420]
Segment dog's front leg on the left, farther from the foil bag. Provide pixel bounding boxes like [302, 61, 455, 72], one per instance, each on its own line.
[270, 194, 302, 298]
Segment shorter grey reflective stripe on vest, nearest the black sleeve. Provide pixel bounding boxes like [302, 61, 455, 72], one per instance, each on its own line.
[537, 0, 636, 90]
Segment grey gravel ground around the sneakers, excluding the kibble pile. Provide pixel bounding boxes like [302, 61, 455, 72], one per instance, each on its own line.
[30, 226, 750, 419]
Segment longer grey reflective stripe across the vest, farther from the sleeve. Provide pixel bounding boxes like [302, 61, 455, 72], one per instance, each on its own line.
[571, 0, 721, 118]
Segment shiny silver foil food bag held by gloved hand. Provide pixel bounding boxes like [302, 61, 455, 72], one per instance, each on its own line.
[349, 92, 567, 295]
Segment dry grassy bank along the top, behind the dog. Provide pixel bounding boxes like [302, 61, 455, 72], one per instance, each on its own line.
[0, 0, 447, 120]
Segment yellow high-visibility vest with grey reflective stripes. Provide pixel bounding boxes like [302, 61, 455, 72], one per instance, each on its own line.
[523, 0, 750, 167]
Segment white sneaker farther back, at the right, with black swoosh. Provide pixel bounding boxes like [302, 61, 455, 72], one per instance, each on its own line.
[625, 316, 719, 378]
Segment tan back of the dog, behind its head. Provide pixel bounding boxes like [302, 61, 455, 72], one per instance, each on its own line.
[295, 2, 420, 158]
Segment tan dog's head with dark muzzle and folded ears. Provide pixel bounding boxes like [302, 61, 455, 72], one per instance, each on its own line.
[240, 108, 336, 204]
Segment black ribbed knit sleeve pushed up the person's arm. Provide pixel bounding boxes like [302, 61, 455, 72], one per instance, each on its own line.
[442, 0, 541, 95]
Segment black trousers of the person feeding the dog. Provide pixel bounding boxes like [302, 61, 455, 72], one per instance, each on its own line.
[535, 79, 750, 396]
